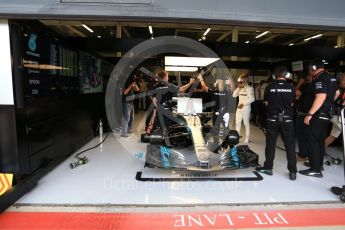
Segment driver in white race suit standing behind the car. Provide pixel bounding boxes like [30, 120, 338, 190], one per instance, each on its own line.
[232, 73, 255, 144]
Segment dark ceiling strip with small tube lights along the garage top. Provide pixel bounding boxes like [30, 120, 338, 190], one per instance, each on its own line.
[41, 20, 344, 47]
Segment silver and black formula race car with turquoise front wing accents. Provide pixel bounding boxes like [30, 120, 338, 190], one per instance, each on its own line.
[141, 98, 258, 171]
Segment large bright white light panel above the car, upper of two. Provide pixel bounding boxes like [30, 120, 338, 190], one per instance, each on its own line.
[164, 56, 219, 67]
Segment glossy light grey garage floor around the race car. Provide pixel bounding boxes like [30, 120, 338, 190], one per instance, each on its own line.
[17, 114, 344, 205]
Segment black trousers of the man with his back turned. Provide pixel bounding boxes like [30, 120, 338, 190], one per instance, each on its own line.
[264, 118, 297, 173]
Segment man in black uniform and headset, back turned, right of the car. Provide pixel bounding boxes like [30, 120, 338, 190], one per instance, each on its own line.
[256, 66, 297, 180]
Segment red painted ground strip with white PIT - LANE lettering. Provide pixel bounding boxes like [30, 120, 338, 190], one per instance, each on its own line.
[0, 208, 345, 230]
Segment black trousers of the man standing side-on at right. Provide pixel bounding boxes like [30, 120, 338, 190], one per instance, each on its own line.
[306, 117, 329, 172]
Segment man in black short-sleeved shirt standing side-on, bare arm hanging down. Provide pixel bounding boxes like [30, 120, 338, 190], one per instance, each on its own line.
[299, 60, 337, 178]
